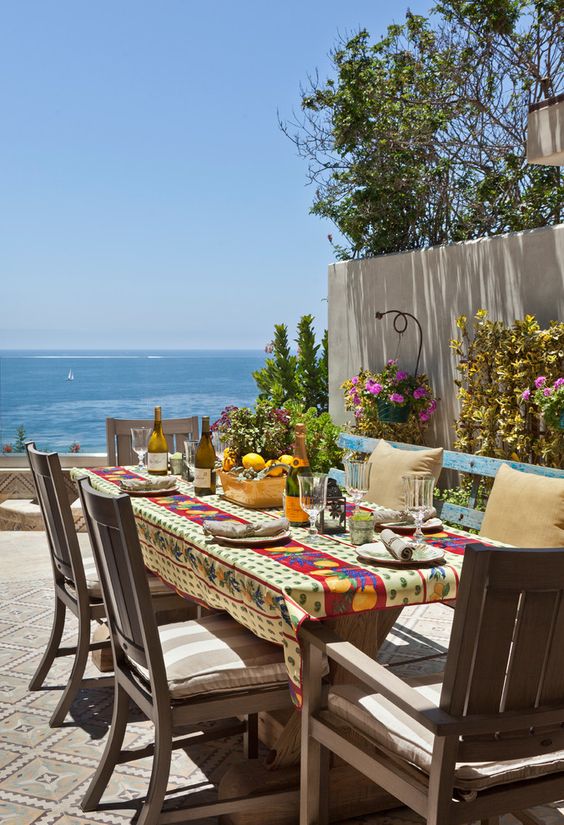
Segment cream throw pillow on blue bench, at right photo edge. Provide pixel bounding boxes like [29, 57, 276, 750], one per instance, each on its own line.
[480, 464, 564, 547]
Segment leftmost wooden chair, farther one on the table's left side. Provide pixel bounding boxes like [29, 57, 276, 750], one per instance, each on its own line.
[26, 442, 196, 727]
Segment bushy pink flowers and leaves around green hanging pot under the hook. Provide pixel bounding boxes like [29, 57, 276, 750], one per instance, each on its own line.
[341, 359, 437, 443]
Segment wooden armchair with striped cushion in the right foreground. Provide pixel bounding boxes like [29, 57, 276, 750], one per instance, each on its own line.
[300, 544, 564, 825]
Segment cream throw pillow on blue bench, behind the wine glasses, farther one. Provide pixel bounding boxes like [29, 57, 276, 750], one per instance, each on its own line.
[366, 440, 443, 510]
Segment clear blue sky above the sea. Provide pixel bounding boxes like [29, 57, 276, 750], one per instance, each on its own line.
[0, 0, 429, 348]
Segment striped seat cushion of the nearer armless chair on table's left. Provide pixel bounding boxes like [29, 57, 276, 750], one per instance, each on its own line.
[127, 613, 288, 699]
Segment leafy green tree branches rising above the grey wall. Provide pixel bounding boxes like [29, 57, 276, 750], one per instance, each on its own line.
[281, 0, 564, 258]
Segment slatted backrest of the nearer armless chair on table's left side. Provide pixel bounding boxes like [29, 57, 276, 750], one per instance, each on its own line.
[78, 470, 168, 695]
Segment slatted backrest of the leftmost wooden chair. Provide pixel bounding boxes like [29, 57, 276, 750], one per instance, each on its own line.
[25, 441, 86, 594]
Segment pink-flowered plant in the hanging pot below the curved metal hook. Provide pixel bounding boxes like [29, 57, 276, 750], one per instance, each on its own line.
[342, 359, 437, 432]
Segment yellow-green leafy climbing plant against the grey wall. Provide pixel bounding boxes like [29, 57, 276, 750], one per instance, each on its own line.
[451, 310, 564, 467]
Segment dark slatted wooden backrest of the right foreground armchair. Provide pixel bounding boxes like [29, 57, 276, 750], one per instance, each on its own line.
[441, 544, 564, 761]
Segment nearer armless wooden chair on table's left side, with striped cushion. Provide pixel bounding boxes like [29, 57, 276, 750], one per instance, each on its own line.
[78, 479, 298, 825]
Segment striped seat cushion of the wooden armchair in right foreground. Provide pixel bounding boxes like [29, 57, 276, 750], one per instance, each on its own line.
[328, 683, 564, 791]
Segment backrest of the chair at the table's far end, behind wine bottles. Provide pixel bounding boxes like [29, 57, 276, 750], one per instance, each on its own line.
[106, 415, 199, 466]
